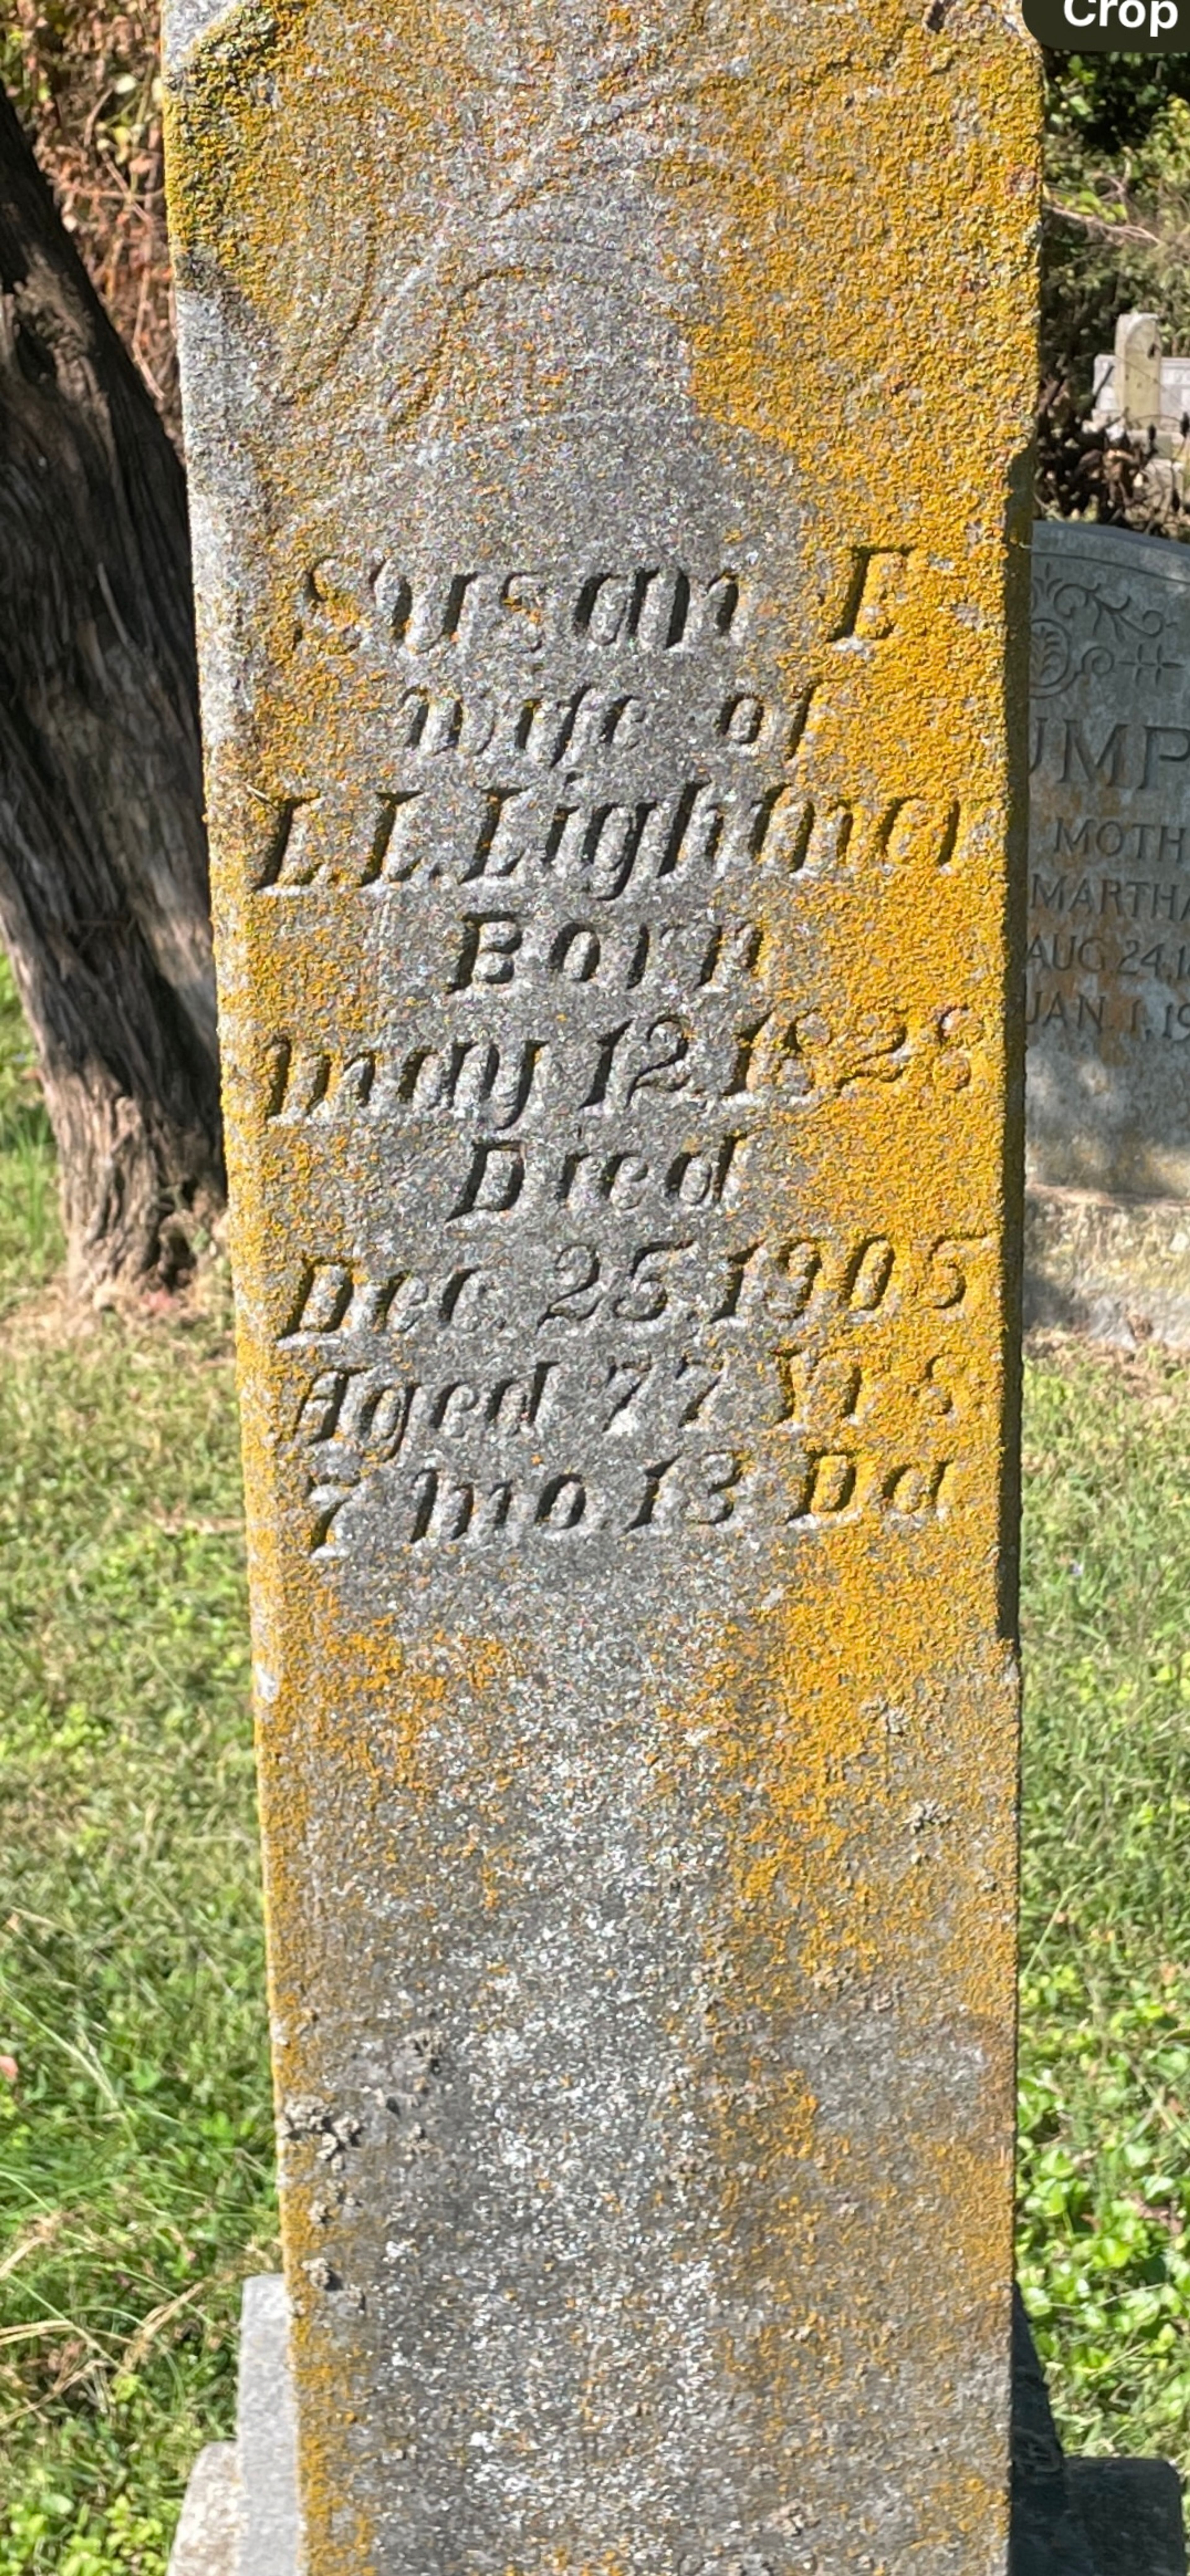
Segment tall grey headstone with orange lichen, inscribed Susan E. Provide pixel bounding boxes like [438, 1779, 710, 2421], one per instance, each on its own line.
[170, 0, 1038, 2576]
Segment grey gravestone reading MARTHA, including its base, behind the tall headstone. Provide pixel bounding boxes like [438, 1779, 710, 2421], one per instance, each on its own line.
[1025, 520, 1190, 1342]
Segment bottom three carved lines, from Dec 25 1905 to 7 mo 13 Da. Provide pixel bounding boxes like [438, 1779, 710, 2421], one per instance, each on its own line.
[278, 1237, 989, 1553]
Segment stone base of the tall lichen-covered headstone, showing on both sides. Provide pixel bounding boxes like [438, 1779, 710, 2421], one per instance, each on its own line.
[170, 2274, 1188, 2576]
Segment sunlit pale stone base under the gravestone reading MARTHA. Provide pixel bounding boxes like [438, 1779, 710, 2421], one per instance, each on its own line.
[1025, 1188, 1190, 1350]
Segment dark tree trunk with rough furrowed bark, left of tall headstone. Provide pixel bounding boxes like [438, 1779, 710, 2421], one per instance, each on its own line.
[0, 90, 224, 1296]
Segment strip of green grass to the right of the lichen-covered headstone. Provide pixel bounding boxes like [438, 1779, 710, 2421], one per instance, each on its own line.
[1020, 1345, 1190, 2470]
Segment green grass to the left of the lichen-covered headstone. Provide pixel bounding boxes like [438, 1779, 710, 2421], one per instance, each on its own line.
[0, 953, 275, 2576]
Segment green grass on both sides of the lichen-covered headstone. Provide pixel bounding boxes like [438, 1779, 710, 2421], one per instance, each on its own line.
[0, 976, 1190, 2576]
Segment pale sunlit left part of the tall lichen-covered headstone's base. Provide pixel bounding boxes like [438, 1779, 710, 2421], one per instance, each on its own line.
[170, 2272, 299, 2576]
